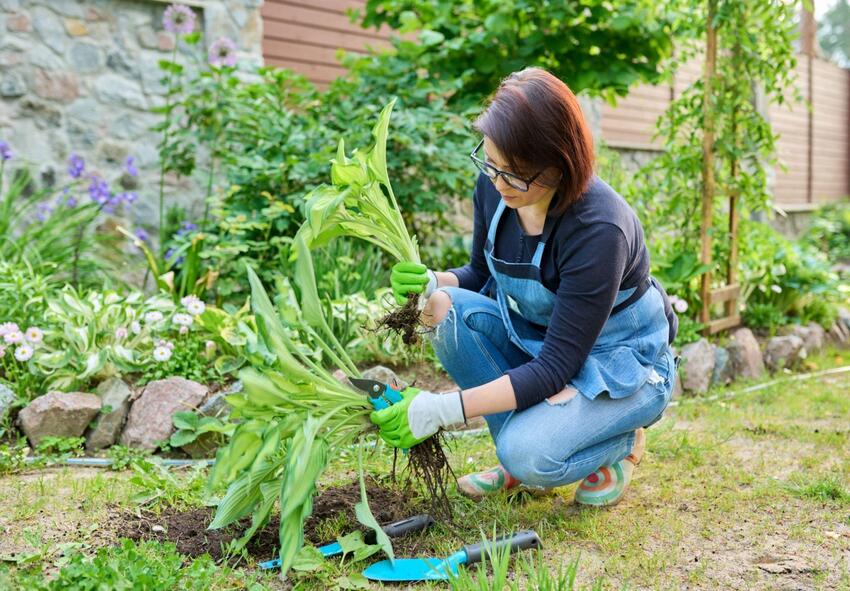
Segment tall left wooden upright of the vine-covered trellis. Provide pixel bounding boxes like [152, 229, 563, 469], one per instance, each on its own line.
[700, 0, 717, 333]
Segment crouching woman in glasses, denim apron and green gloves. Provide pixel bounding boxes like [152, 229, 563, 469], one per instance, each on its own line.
[372, 68, 678, 505]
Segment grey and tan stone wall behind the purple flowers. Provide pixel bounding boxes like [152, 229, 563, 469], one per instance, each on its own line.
[0, 0, 262, 240]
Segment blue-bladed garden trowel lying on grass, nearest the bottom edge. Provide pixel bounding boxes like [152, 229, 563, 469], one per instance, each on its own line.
[363, 530, 542, 582]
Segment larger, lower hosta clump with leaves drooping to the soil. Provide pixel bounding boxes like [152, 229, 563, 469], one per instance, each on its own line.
[209, 251, 392, 573]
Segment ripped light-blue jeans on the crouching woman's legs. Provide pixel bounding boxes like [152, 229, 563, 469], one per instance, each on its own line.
[430, 287, 675, 488]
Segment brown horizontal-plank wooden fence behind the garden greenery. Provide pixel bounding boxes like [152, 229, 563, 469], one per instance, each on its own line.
[262, 0, 850, 209]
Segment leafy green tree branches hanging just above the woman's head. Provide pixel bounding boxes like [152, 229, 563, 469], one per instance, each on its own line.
[362, 0, 672, 104]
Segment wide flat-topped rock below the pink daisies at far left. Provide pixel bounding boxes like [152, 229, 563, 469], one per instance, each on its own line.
[18, 392, 100, 447]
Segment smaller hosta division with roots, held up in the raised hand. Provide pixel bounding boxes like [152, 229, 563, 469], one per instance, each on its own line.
[298, 100, 428, 344]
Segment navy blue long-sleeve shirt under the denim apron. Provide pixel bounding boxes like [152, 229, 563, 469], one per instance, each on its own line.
[449, 174, 673, 410]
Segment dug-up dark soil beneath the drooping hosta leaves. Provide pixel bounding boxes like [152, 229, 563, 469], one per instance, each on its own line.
[110, 479, 419, 560]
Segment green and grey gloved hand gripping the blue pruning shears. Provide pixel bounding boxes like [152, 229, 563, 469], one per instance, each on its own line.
[369, 388, 466, 449]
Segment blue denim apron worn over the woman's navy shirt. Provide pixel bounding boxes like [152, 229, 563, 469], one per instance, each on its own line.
[481, 201, 669, 400]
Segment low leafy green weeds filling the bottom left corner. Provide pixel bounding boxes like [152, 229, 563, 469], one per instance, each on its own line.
[0, 540, 263, 591]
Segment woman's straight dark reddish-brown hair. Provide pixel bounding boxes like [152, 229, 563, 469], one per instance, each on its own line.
[474, 68, 593, 215]
